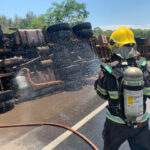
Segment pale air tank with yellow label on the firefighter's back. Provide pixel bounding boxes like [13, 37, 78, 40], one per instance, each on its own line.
[123, 67, 144, 122]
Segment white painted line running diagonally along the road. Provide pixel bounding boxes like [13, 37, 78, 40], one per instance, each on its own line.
[42, 102, 108, 150]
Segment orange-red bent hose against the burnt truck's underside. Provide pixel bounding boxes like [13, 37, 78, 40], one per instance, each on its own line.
[20, 68, 63, 86]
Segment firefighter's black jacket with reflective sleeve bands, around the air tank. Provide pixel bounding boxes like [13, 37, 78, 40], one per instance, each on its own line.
[94, 57, 150, 118]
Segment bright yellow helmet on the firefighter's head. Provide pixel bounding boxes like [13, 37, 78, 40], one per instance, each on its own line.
[108, 27, 136, 51]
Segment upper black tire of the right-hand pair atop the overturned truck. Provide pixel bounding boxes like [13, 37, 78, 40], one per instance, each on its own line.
[72, 22, 92, 33]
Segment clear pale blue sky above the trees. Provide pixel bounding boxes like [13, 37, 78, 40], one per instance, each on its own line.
[0, 0, 150, 30]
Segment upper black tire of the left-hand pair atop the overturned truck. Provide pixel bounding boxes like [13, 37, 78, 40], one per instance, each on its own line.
[47, 23, 71, 33]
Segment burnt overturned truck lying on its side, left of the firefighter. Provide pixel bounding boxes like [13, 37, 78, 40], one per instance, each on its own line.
[0, 22, 100, 111]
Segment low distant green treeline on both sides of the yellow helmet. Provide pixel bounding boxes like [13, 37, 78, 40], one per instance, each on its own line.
[93, 27, 150, 38]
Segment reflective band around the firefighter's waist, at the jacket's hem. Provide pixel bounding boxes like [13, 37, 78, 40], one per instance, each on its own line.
[106, 109, 149, 124]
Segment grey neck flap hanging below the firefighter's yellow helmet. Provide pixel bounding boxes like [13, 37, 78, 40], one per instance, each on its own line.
[113, 46, 140, 60]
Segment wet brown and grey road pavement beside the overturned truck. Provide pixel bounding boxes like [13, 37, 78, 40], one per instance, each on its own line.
[0, 86, 150, 150]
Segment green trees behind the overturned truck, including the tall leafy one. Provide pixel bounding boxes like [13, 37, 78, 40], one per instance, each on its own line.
[0, 0, 89, 33]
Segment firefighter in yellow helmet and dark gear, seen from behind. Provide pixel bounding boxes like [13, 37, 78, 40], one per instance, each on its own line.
[94, 27, 150, 150]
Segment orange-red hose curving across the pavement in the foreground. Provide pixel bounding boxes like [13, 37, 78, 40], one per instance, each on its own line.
[0, 122, 98, 150]
